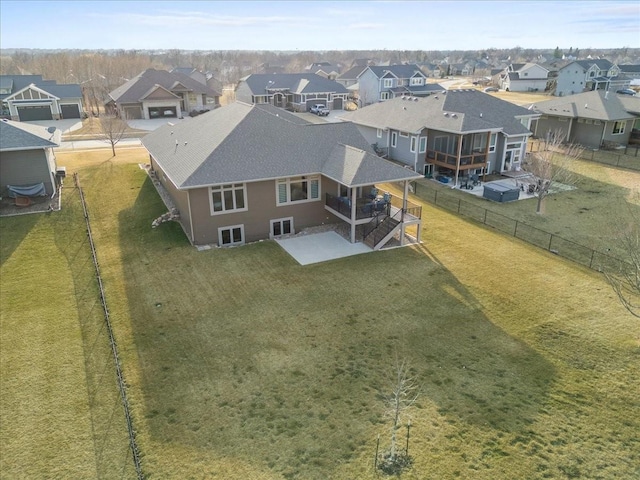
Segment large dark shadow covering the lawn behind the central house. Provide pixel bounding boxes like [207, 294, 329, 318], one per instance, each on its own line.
[112, 172, 555, 478]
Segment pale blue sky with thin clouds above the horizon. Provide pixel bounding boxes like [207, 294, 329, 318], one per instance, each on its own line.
[0, 0, 640, 51]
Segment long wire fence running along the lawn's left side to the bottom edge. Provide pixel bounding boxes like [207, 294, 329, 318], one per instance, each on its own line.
[66, 174, 144, 480]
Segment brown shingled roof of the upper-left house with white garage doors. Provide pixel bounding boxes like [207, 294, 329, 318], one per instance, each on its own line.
[109, 68, 220, 103]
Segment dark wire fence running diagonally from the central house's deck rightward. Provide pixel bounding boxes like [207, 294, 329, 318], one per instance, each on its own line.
[412, 180, 630, 272]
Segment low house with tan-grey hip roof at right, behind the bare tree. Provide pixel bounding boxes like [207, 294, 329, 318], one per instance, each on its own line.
[532, 90, 640, 148]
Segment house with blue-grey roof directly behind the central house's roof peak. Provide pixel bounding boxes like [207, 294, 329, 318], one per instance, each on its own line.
[236, 73, 349, 112]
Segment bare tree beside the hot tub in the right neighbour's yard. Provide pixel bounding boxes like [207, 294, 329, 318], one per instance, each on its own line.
[523, 130, 582, 214]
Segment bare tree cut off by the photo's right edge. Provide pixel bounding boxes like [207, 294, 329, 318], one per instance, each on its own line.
[603, 203, 640, 318]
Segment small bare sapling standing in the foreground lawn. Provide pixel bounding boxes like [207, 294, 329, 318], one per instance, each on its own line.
[379, 359, 420, 474]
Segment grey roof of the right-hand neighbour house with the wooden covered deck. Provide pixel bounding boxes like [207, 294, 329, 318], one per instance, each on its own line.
[341, 90, 538, 136]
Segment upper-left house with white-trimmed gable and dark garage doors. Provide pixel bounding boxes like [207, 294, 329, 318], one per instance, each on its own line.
[0, 75, 84, 122]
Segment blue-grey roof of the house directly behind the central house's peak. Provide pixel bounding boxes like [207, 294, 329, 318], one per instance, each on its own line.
[243, 73, 348, 95]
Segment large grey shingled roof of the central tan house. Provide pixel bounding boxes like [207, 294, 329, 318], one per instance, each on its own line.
[142, 102, 420, 189]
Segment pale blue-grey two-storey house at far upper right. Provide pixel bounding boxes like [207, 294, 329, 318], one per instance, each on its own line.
[554, 59, 629, 97]
